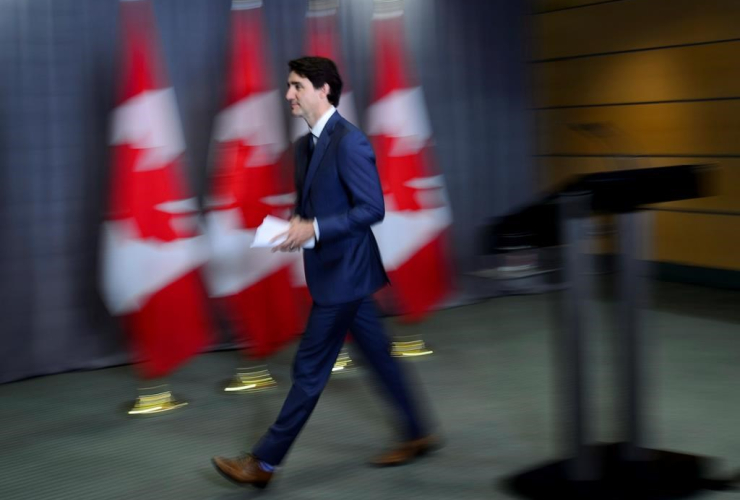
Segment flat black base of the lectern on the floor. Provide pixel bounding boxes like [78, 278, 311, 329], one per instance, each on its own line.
[506, 444, 712, 500]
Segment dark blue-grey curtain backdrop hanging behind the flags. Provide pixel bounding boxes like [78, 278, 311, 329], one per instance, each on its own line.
[0, 0, 534, 382]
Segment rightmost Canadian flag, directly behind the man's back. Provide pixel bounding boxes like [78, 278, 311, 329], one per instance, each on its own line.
[367, 2, 452, 320]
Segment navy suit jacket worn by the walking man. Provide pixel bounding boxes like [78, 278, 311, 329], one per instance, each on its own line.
[295, 112, 388, 305]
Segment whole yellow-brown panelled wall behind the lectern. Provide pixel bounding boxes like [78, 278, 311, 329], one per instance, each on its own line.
[530, 0, 740, 270]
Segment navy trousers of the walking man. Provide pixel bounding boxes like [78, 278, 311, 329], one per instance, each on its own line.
[252, 297, 426, 465]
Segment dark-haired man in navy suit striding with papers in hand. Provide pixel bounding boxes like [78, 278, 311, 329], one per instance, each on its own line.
[213, 57, 438, 488]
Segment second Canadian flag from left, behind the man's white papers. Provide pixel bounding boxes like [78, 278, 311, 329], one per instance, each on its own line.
[206, 1, 307, 358]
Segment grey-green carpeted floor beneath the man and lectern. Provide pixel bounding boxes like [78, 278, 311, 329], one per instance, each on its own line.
[0, 283, 740, 500]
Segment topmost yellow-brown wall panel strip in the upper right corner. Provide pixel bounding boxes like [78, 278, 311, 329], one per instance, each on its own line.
[532, 0, 740, 59]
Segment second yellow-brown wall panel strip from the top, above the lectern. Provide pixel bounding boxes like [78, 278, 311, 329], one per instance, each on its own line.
[531, 42, 740, 108]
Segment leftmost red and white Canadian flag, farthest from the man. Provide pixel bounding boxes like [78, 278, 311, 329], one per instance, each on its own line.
[101, 0, 211, 377]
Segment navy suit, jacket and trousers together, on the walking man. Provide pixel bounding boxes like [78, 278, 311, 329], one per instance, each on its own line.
[253, 112, 425, 465]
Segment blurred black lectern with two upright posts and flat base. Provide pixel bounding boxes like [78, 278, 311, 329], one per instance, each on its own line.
[484, 165, 716, 500]
